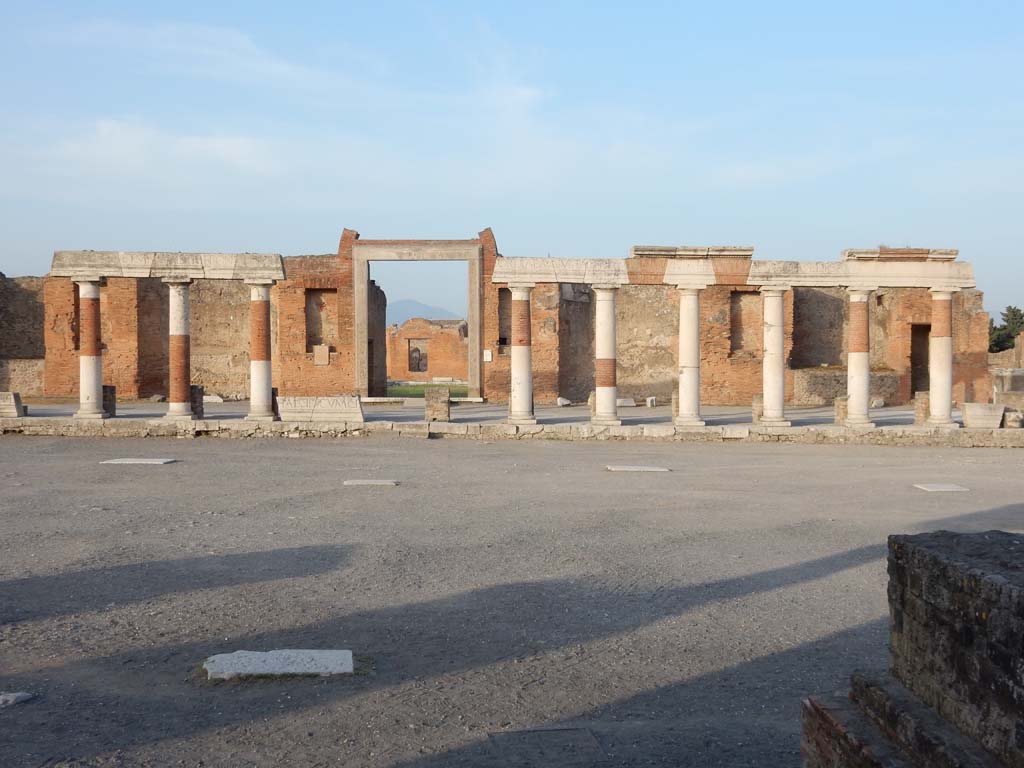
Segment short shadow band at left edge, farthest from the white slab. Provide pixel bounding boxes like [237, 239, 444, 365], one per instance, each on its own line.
[0, 546, 349, 625]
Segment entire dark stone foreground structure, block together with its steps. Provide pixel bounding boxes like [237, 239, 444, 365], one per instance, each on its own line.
[803, 530, 1024, 768]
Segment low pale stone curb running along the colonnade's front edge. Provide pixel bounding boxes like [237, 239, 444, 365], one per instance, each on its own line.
[0, 417, 1024, 447]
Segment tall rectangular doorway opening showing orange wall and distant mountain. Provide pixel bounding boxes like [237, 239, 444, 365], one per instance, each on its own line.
[368, 259, 471, 397]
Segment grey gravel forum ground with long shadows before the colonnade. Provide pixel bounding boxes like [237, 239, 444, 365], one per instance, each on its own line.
[0, 436, 1024, 768]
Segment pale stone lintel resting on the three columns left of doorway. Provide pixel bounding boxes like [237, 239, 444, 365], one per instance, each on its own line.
[50, 251, 285, 280]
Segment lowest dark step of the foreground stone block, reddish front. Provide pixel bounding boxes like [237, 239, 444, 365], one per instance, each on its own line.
[800, 693, 914, 768]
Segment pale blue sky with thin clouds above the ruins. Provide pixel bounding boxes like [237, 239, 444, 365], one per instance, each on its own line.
[0, 0, 1024, 311]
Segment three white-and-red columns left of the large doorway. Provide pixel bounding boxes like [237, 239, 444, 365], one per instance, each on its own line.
[75, 278, 274, 421]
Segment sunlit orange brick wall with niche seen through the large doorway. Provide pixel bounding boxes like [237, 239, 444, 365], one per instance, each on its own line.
[387, 317, 469, 381]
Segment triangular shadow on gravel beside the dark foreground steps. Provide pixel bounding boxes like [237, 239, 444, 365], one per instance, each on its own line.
[394, 617, 889, 768]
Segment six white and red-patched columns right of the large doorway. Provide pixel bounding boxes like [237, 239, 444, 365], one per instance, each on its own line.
[509, 283, 955, 428]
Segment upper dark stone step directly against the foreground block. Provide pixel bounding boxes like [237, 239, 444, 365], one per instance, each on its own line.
[850, 672, 1002, 768]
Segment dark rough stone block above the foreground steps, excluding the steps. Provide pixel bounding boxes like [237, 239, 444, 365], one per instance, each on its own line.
[889, 530, 1024, 768]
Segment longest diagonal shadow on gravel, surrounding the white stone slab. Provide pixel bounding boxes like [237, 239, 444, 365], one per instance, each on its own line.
[0, 545, 885, 762]
